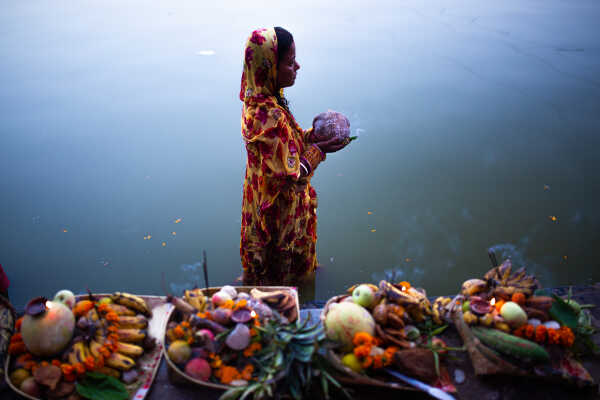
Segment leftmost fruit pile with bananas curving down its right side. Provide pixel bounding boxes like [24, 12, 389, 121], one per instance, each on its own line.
[9, 290, 156, 400]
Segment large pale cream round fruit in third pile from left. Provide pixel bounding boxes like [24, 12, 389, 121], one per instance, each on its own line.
[325, 302, 375, 352]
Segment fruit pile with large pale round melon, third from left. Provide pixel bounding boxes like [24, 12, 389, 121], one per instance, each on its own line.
[322, 280, 455, 391]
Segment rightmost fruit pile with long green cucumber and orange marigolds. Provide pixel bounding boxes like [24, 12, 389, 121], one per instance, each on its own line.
[440, 259, 593, 384]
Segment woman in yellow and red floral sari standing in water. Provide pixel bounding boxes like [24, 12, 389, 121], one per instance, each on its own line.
[240, 27, 348, 287]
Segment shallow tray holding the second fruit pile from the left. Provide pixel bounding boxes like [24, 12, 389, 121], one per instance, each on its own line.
[161, 286, 300, 390]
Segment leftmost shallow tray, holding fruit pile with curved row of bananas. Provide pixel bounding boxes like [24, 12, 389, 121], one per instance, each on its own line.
[5, 293, 173, 400]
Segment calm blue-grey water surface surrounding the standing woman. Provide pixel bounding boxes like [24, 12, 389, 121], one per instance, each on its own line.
[0, 0, 600, 307]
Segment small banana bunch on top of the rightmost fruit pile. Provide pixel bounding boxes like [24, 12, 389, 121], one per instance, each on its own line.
[484, 259, 540, 299]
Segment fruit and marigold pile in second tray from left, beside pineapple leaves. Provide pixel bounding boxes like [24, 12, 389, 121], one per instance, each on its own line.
[165, 286, 298, 386]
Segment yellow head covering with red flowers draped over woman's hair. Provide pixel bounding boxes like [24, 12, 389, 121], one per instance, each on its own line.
[240, 28, 277, 104]
